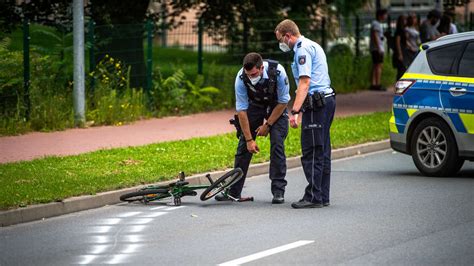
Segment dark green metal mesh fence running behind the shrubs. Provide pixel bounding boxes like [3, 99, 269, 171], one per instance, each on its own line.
[0, 13, 474, 120]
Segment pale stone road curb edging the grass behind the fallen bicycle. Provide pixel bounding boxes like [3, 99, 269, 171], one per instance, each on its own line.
[0, 140, 390, 227]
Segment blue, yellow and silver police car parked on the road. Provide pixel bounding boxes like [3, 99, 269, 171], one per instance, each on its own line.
[389, 31, 474, 176]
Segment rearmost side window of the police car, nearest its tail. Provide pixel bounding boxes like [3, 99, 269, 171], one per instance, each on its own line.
[428, 43, 464, 75]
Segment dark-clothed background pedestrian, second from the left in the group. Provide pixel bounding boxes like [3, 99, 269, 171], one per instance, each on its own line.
[392, 15, 407, 80]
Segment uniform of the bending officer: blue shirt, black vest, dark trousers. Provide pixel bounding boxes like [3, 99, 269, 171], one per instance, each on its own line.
[229, 61, 290, 198]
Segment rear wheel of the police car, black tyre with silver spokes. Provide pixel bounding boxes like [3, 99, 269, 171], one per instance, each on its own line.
[411, 117, 464, 176]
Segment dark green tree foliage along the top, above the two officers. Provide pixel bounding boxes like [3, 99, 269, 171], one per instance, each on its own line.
[169, 0, 368, 57]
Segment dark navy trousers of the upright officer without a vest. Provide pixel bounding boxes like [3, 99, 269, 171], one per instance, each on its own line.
[301, 96, 336, 203]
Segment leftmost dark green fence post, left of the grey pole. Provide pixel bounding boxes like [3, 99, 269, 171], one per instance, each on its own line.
[23, 18, 31, 120]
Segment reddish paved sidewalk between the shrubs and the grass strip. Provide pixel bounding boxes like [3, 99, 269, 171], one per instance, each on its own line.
[0, 91, 393, 163]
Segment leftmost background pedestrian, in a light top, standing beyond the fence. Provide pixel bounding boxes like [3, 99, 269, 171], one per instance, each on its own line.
[369, 9, 387, 90]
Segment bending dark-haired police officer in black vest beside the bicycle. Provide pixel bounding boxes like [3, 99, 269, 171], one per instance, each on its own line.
[215, 53, 290, 204]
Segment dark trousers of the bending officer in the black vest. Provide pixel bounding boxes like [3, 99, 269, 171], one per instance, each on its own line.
[229, 105, 288, 197]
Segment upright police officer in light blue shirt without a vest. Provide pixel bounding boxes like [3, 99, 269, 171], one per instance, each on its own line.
[275, 19, 336, 209]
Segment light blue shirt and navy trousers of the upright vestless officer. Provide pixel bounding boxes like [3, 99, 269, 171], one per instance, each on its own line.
[292, 36, 336, 204]
